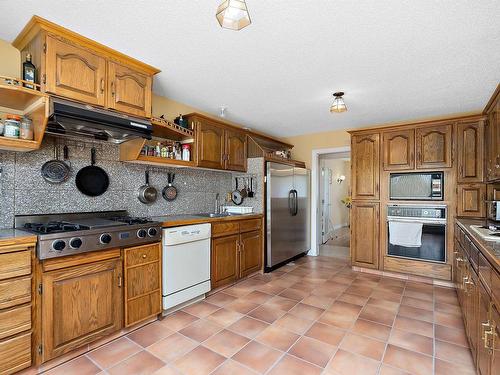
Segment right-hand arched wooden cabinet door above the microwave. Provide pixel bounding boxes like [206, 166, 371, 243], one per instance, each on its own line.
[416, 124, 453, 169]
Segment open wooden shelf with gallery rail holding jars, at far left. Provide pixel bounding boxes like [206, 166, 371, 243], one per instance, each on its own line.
[0, 76, 49, 151]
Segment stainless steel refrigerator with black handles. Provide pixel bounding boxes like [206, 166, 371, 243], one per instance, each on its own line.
[265, 162, 311, 270]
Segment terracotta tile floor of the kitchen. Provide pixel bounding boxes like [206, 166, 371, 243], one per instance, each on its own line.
[41, 256, 475, 375]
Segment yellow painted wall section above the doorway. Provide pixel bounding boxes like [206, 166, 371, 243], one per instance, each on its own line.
[284, 130, 351, 168]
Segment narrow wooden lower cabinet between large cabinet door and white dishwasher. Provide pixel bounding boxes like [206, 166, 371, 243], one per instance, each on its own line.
[123, 243, 162, 327]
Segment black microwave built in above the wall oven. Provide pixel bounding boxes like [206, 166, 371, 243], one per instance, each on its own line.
[389, 172, 444, 201]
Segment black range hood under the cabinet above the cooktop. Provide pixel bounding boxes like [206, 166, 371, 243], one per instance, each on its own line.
[45, 98, 153, 143]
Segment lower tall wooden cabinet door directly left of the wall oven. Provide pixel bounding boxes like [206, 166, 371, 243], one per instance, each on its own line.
[351, 202, 380, 269]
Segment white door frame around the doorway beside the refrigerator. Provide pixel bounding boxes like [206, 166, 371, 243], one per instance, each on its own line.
[307, 146, 351, 256]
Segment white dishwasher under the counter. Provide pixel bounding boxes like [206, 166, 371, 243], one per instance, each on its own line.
[162, 224, 211, 310]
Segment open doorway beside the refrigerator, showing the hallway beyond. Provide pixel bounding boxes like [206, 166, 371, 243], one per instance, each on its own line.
[317, 152, 351, 260]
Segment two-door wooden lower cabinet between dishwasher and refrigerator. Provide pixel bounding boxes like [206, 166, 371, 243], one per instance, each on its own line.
[210, 219, 263, 289]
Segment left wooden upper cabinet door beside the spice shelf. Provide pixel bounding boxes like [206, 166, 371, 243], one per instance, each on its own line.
[196, 121, 225, 169]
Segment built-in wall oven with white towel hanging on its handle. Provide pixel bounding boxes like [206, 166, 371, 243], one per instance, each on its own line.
[387, 204, 446, 263]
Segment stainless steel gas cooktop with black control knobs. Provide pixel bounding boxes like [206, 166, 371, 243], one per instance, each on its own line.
[15, 211, 161, 259]
